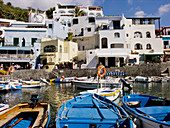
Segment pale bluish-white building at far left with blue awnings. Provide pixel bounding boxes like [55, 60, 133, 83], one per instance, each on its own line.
[0, 20, 68, 68]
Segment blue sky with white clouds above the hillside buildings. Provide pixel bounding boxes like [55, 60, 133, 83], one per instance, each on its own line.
[3, 0, 170, 27]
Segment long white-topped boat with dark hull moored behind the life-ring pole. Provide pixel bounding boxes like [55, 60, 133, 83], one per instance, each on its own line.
[72, 77, 121, 89]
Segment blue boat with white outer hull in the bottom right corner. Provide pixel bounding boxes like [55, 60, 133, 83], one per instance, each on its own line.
[122, 94, 170, 128]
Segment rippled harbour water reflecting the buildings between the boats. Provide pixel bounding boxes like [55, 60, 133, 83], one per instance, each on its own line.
[0, 82, 170, 128]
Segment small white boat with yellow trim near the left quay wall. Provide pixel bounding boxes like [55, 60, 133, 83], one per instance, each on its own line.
[20, 80, 42, 88]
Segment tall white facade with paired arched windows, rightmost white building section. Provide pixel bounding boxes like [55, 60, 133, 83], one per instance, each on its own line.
[122, 17, 163, 62]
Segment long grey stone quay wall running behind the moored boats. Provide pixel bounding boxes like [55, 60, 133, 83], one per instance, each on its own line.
[0, 62, 170, 80]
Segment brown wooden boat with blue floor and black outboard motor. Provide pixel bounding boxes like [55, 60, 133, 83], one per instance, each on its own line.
[0, 95, 50, 128]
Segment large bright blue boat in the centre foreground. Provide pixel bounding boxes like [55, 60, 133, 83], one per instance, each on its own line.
[56, 93, 133, 128]
